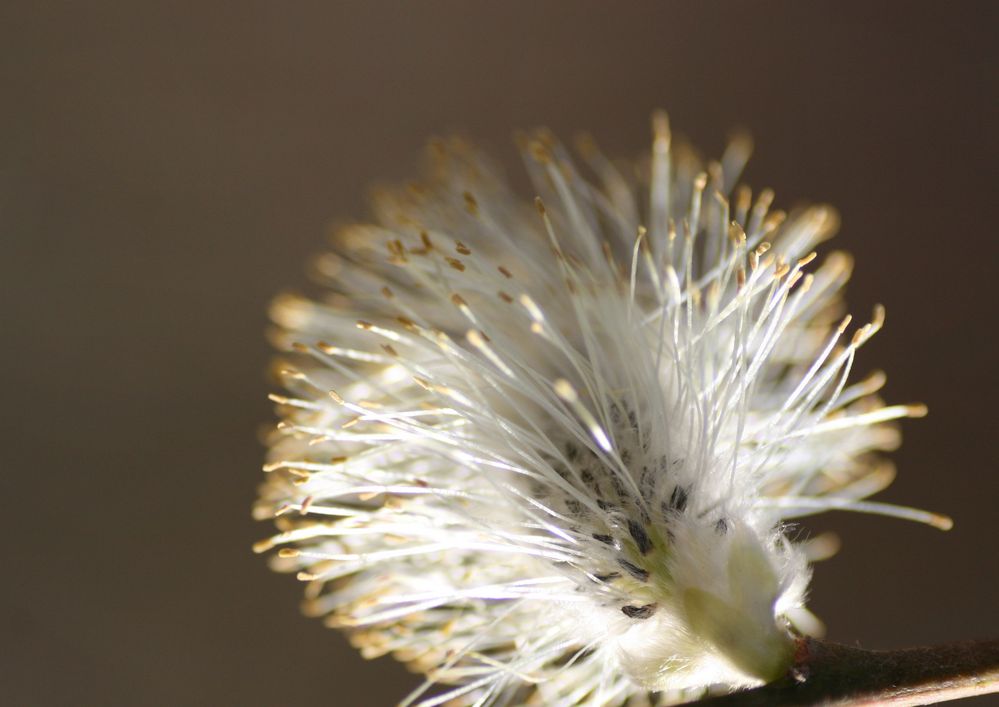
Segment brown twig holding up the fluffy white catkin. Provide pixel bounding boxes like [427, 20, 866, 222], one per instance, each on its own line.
[696, 639, 999, 707]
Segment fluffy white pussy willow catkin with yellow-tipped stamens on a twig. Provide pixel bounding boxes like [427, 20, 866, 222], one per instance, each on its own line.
[255, 114, 949, 705]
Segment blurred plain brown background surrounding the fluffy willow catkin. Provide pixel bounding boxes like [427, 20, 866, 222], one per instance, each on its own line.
[0, 0, 999, 706]
